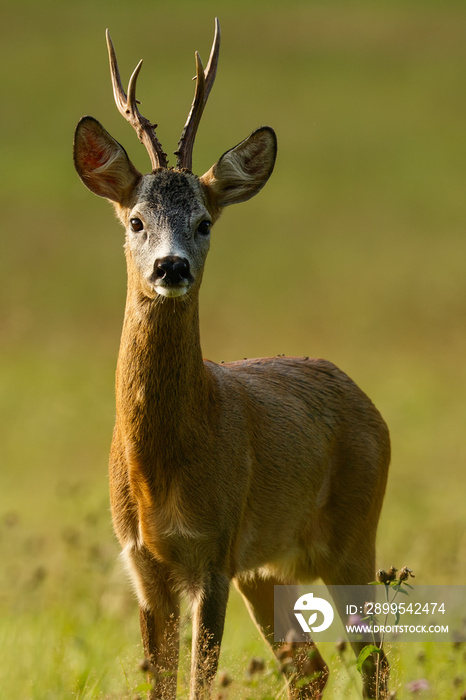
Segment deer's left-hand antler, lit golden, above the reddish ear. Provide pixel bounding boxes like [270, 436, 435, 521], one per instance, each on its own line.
[106, 29, 168, 170]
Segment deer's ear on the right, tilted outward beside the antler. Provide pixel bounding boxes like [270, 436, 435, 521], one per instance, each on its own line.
[201, 126, 277, 208]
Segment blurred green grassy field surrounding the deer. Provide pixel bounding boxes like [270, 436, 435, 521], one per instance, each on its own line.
[0, 0, 466, 700]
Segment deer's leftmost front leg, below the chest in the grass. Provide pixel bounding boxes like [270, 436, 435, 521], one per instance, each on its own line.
[125, 547, 180, 700]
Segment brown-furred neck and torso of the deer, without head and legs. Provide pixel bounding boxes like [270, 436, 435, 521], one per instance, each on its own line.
[110, 266, 389, 697]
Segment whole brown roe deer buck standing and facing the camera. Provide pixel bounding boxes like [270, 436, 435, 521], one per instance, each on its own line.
[74, 21, 390, 700]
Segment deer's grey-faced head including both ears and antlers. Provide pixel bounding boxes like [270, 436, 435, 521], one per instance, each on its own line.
[74, 20, 277, 299]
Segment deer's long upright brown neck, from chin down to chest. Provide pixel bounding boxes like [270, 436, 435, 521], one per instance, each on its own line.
[116, 260, 209, 479]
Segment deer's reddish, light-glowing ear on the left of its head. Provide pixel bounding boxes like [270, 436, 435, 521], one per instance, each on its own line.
[74, 117, 142, 204]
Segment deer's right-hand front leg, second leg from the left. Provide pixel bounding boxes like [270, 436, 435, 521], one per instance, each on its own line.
[189, 574, 230, 700]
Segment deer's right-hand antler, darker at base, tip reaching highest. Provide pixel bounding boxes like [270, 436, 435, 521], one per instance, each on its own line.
[175, 17, 220, 170]
